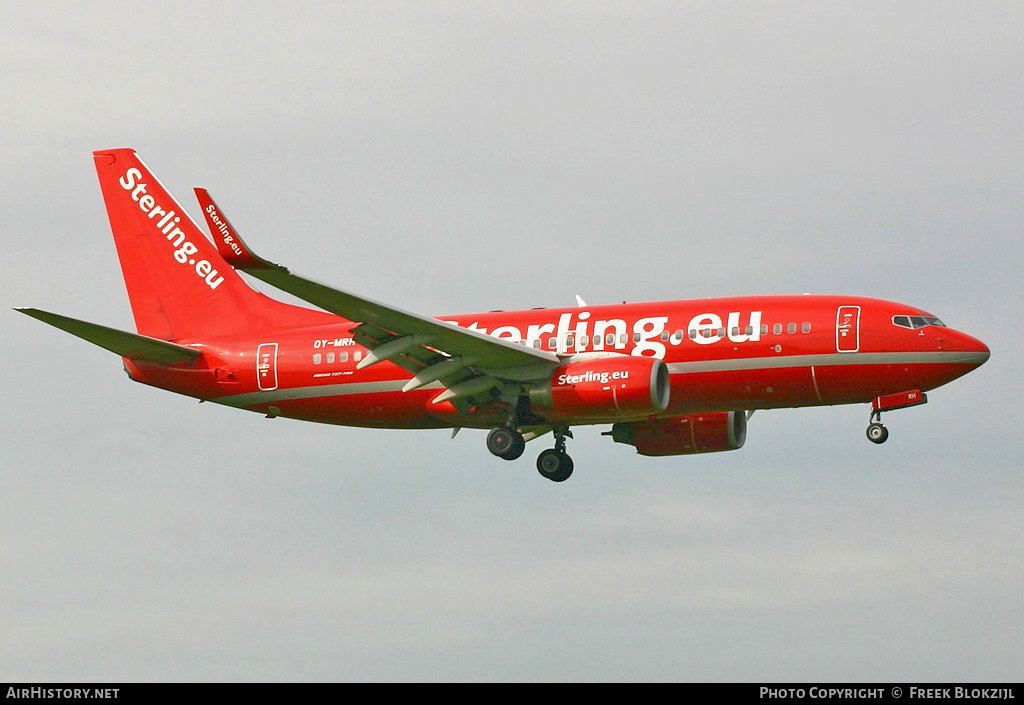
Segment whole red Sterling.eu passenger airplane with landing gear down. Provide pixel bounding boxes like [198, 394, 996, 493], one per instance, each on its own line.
[18, 149, 989, 482]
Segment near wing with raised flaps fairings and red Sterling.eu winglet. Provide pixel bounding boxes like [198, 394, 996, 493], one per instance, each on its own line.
[196, 189, 560, 402]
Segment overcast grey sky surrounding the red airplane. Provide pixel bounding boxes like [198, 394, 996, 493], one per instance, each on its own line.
[0, 1, 1024, 681]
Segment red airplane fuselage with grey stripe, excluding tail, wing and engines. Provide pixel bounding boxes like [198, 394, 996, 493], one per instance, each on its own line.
[125, 295, 988, 428]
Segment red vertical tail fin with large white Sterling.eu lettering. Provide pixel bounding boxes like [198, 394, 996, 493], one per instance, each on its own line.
[93, 149, 324, 340]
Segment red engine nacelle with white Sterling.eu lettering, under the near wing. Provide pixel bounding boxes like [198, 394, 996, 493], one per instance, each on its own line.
[528, 355, 670, 419]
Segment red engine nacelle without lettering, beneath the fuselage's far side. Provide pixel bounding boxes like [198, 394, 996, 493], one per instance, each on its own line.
[605, 411, 746, 455]
